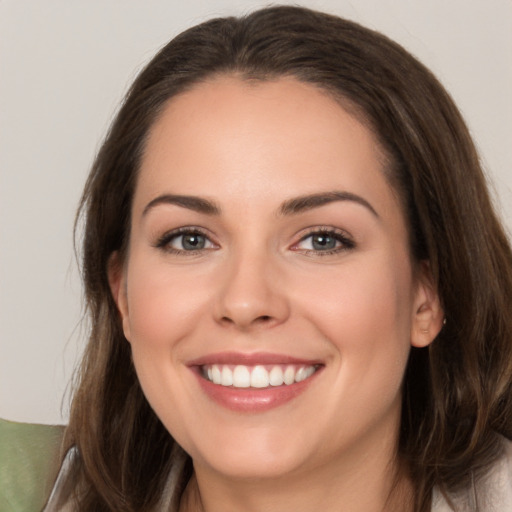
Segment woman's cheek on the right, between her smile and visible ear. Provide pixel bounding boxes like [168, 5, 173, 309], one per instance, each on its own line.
[290, 265, 411, 442]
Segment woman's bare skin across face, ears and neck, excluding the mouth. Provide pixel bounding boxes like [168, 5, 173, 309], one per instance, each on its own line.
[110, 76, 442, 512]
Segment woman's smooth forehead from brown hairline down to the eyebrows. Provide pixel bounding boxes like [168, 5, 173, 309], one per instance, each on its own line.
[132, 76, 409, 256]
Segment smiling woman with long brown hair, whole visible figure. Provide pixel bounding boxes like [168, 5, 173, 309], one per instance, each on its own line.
[48, 7, 512, 512]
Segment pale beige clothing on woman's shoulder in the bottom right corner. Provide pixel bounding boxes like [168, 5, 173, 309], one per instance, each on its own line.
[432, 438, 512, 512]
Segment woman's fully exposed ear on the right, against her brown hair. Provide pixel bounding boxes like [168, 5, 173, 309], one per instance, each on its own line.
[411, 261, 444, 347]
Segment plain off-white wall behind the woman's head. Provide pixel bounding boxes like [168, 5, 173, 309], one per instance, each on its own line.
[0, 0, 512, 423]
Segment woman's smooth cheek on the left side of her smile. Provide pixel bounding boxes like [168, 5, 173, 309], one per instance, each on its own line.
[122, 252, 206, 432]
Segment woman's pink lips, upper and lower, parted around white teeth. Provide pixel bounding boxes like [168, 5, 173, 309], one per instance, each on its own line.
[187, 352, 324, 413]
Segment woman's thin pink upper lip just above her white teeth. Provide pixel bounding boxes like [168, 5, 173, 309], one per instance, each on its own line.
[187, 352, 322, 366]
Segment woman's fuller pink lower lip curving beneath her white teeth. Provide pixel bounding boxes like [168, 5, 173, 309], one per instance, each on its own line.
[194, 368, 322, 413]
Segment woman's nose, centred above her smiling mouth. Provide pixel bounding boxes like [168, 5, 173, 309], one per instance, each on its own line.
[215, 247, 290, 330]
